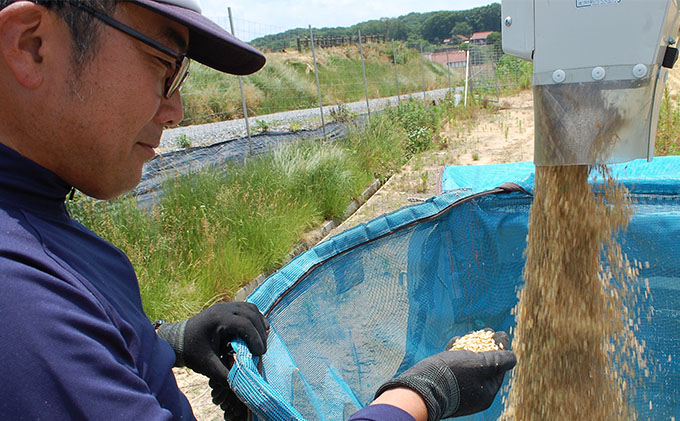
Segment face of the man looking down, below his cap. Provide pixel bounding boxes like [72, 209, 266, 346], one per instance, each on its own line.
[44, 3, 188, 199]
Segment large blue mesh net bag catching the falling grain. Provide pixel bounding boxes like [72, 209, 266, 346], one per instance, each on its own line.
[229, 157, 680, 421]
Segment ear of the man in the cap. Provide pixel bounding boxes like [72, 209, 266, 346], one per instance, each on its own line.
[0, 1, 47, 89]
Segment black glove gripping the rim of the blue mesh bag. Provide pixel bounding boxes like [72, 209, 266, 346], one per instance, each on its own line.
[157, 302, 269, 387]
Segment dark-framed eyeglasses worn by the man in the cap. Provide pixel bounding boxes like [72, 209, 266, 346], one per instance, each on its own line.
[66, 0, 191, 99]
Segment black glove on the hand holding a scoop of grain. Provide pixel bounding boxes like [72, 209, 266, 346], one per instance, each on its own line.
[375, 332, 517, 421]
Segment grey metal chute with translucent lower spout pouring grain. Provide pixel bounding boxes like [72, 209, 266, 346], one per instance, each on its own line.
[502, 0, 680, 166]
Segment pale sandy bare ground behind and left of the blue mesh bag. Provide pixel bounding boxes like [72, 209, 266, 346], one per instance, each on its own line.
[175, 87, 534, 421]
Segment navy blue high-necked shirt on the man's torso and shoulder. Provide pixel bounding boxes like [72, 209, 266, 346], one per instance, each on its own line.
[0, 144, 194, 420]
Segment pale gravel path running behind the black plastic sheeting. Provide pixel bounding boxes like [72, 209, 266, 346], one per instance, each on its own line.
[158, 88, 462, 153]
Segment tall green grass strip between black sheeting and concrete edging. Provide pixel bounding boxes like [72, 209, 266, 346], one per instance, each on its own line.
[69, 100, 469, 320]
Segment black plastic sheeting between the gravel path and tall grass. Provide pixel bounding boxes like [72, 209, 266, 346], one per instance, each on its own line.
[132, 115, 366, 209]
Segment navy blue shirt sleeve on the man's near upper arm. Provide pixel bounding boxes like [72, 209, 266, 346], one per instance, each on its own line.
[0, 256, 187, 420]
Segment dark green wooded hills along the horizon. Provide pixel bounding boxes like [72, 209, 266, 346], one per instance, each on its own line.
[251, 3, 501, 51]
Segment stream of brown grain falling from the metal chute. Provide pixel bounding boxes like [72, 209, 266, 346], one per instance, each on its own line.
[504, 166, 644, 420]
